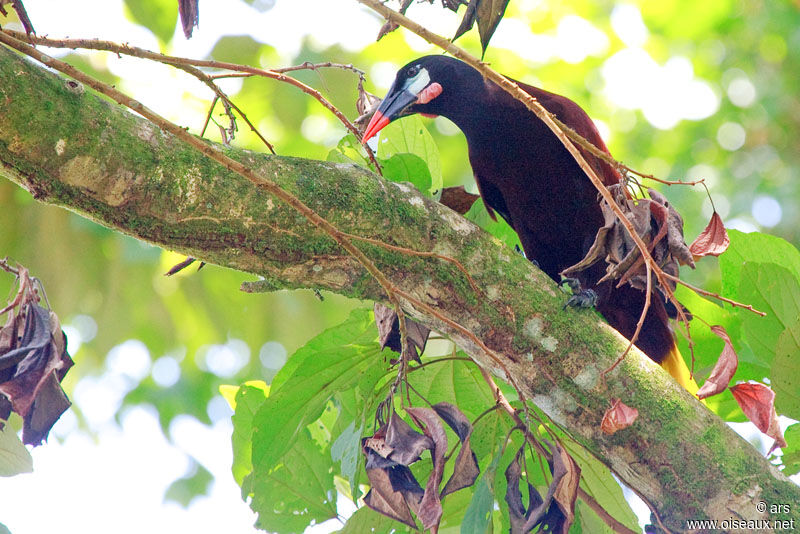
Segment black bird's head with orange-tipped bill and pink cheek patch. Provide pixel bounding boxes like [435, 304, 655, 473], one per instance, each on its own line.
[361, 56, 465, 143]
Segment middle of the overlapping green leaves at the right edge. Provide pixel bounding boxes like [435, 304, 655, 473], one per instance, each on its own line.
[737, 262, 800, 366]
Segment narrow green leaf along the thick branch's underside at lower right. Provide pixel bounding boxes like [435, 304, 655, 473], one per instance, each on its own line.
[564, 439, 640, 532]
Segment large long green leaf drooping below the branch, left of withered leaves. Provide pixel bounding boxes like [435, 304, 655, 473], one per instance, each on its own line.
[253, 309, 386, 480]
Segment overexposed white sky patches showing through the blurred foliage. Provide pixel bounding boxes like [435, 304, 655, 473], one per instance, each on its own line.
[0, 0, 792, 534]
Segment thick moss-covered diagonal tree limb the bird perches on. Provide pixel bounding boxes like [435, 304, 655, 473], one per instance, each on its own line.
[0, 48, 800, 531]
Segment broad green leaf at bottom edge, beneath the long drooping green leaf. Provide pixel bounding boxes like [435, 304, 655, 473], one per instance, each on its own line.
[247, 429, 336, 533]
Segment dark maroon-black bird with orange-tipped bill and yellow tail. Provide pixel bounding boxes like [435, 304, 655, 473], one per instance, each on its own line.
[362, 55, 697, 393]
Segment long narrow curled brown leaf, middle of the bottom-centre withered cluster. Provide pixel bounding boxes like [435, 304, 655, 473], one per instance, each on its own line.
[406, 408, 447, 529]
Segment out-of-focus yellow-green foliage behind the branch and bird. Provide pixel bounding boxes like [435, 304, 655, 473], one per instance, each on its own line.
[0, 0, 800, 532]
